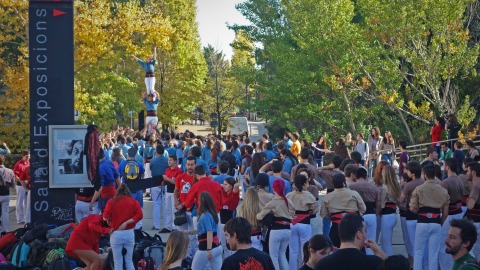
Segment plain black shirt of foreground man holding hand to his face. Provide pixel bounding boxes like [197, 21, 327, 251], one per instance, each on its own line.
[315, 248, 383, 270]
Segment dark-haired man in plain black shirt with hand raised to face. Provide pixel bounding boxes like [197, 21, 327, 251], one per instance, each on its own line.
[315, 214, 387, 270]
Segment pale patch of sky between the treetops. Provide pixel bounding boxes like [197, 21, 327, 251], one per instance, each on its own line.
[197, 0, 249, 59]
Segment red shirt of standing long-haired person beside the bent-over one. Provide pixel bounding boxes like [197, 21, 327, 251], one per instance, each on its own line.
[103, 195, 143, 230]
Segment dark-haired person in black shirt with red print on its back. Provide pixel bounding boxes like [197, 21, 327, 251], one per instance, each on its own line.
[222, 217, 275, 270]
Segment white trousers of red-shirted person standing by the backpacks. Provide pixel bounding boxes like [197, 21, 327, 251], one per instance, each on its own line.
[110, 229, 135, 270]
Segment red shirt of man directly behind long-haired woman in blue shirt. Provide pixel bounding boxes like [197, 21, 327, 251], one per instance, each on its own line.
[185, 177, 223, 212]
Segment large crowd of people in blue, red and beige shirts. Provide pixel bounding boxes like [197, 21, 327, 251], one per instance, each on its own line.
[0, 113, 480, 270]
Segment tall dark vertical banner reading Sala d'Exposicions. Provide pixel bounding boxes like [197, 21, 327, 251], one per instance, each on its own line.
[29, 0, 75, 225]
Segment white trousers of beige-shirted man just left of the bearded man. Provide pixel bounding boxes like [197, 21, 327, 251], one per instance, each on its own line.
[413, 223, 444, 270]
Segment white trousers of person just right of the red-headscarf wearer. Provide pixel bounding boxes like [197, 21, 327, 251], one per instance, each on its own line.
[288, 223, 312, 270]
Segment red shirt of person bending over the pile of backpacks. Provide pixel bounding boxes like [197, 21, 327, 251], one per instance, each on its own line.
[65, 214, 110, 258]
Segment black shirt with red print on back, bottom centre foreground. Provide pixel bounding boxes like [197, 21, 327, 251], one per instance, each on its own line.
[222, 248, 275, 270]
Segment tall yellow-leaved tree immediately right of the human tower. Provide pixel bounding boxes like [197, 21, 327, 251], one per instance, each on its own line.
[152, 0, 207, 130]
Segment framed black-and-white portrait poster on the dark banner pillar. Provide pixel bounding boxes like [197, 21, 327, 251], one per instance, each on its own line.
[48, 125, 92, 188]
